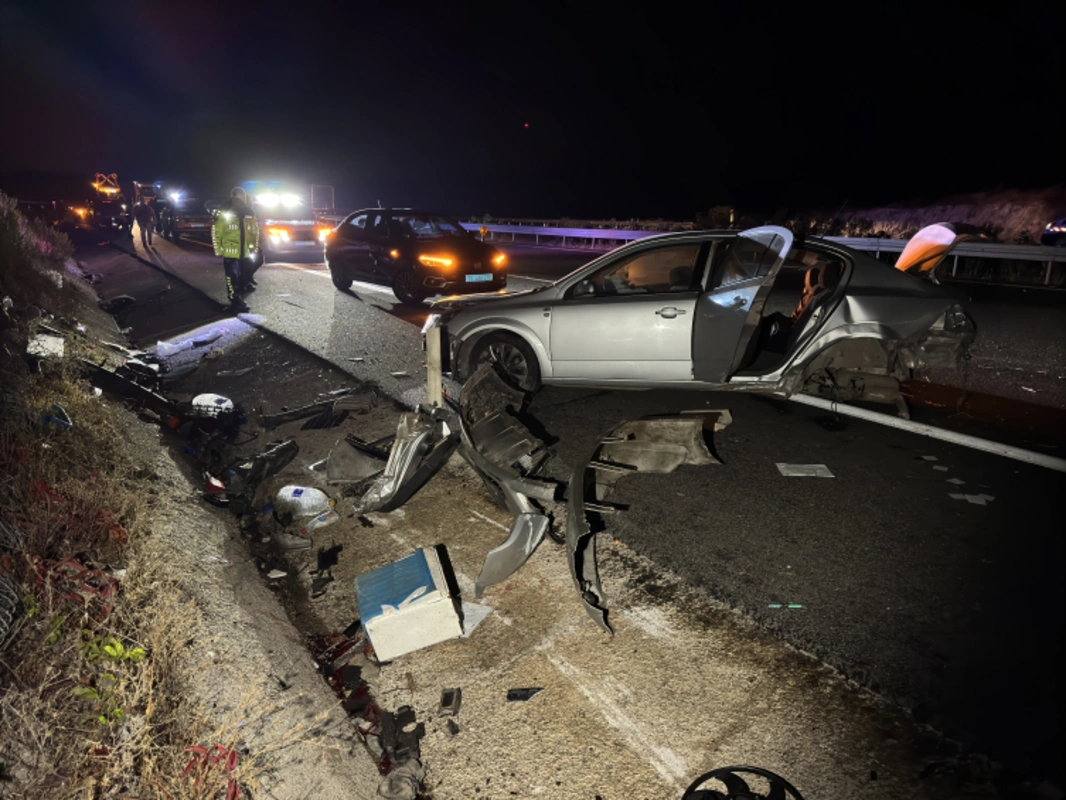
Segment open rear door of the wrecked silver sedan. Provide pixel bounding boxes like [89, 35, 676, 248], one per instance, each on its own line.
[692, 225, 792, 383]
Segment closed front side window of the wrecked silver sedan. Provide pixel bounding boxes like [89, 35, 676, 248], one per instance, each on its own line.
[568, 243, 701, 298]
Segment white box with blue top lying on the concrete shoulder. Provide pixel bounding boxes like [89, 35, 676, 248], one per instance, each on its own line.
[355, 547, 463, 661]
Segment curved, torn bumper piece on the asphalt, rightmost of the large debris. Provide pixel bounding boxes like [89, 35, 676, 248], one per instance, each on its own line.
[566, 411, 732, 634]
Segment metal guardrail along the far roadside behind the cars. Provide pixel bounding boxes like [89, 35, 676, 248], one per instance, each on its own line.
[461, 222, 1066, 286]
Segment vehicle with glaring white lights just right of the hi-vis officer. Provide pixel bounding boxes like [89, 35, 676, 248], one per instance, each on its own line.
[242, 180, 334, 260]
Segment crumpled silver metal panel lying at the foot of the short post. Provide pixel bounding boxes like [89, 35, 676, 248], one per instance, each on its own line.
[356, 411, 459, 514]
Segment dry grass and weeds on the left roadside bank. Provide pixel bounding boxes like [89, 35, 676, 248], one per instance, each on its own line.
[0, 193, 256, 800]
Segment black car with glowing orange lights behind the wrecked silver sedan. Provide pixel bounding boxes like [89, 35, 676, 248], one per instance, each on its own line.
[325, 208, 507, 306]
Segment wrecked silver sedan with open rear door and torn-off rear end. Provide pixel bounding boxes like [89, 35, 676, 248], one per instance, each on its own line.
[426, 226, 974, 403]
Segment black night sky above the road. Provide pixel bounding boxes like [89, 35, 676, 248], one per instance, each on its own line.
[0, 0, 1066, 219]
